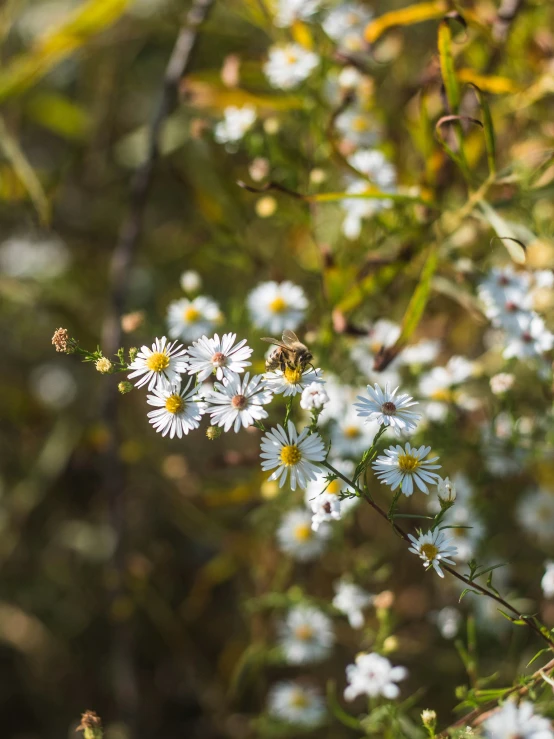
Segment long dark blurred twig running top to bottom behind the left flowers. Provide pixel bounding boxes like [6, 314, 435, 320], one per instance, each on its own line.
[98, 0, 215, 736]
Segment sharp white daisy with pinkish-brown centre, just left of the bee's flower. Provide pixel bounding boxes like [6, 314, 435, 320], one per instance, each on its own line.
[187, 334, 253, 382]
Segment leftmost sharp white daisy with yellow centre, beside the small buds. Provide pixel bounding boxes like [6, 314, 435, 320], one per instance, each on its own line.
[127, 336, 187, 390]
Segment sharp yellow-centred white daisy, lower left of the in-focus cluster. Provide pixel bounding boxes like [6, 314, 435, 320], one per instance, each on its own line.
[147, 379, 204, 439]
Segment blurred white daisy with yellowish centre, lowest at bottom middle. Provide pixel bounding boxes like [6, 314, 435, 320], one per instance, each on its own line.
[267, 680, 325, 727]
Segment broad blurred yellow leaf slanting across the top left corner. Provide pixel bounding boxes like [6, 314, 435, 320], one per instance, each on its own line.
[0, 0, 130, 102]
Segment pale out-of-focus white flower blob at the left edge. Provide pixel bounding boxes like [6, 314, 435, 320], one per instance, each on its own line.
[0, 235, 69, 280]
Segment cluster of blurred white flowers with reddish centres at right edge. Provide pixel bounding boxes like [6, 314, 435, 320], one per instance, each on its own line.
[478, 268, 554, 359]
